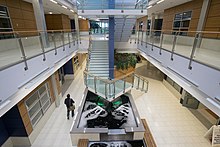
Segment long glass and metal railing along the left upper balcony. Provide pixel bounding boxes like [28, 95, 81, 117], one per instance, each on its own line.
[0, 30, 79, 70]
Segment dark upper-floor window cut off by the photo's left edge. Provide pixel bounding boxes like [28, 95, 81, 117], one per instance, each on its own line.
[0, 6, 13, 39]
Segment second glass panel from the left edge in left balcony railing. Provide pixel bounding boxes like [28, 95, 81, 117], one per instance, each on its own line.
[20, 32, 42, 58]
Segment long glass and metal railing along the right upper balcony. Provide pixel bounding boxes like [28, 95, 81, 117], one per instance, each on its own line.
[134, 30, 220, 70]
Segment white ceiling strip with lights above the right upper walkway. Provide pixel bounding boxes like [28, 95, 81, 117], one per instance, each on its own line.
[147, 0, 192, 17]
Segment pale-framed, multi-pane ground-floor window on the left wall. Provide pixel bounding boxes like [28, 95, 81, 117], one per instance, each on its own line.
[25, 83, 51, 127]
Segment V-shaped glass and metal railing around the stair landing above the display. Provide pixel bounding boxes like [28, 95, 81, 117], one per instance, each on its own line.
[84, 70, 149, 101]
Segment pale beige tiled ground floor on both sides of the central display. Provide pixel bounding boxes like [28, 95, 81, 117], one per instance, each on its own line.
[32, 63, 211, 147]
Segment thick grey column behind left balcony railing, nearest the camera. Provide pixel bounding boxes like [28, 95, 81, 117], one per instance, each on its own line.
[32, 0, 49, 47]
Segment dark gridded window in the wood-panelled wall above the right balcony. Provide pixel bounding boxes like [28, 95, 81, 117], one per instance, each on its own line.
[173, 11, 192, 35]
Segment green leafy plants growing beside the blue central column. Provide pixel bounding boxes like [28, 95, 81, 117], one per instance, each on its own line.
[115, 53, 137, 70]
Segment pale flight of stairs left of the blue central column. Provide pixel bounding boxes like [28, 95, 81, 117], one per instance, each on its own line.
[88, 40, 109, 79]
